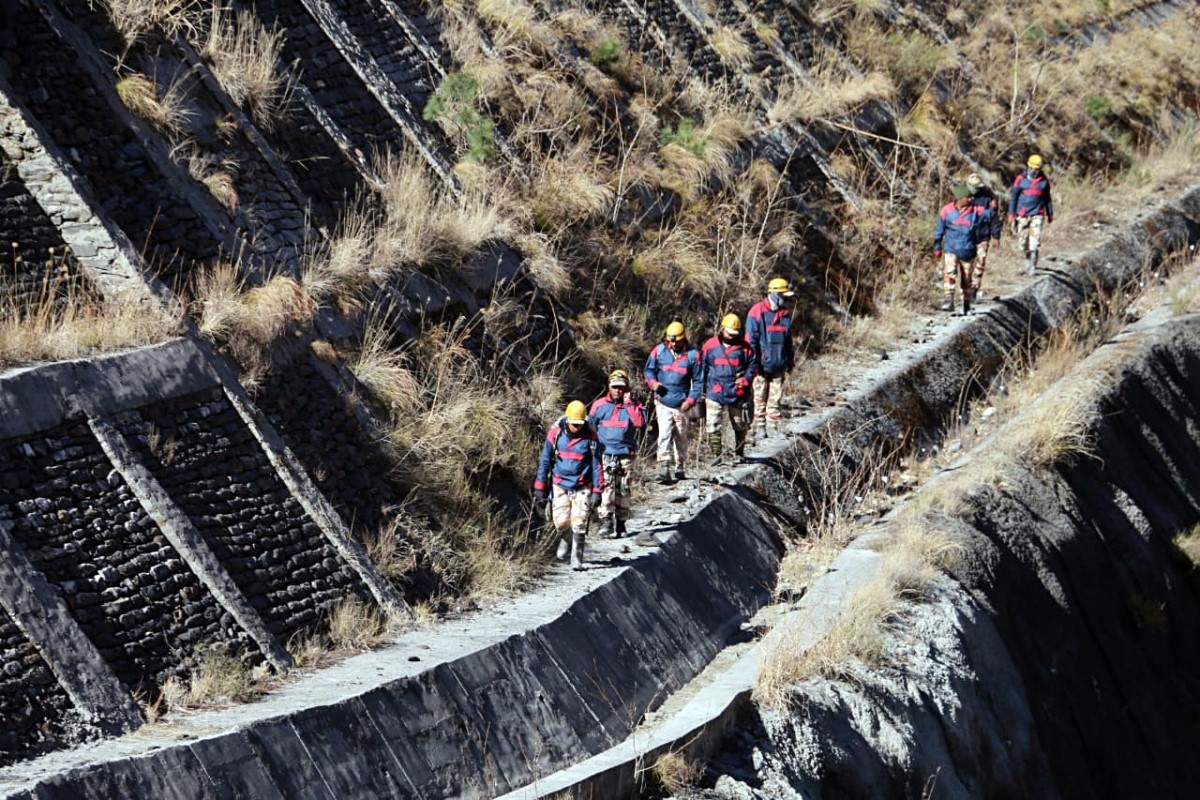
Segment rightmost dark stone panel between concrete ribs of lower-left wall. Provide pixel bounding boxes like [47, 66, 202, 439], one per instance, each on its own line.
[118, 387, 368, 642]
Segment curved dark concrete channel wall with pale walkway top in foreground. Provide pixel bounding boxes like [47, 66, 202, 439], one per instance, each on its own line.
[0, 491, 781, 799]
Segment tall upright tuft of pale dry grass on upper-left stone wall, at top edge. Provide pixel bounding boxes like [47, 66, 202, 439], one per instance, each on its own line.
[200, 1, 293, 131]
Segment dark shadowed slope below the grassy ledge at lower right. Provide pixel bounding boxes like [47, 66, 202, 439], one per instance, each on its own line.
[684, 318, 1200, 799]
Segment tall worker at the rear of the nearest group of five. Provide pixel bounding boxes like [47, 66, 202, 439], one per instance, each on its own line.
[746, 278, 796, 439]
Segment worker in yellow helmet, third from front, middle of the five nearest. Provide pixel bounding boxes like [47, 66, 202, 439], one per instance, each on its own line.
[643, 321, 704, 483]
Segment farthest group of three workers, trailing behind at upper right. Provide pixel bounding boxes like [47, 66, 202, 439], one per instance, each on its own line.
[934, 154, 1054, 314]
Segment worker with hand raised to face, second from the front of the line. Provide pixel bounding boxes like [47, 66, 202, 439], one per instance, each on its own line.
[588, 369, 646, 539]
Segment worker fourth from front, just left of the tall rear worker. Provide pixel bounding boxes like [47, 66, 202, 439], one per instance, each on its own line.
[700, 314, 757, 467]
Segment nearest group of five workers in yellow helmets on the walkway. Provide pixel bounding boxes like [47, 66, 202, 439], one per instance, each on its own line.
[533, 278, 796, 570]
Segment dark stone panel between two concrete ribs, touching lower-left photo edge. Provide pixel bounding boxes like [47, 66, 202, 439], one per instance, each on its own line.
[0, 420, 261, 691]
